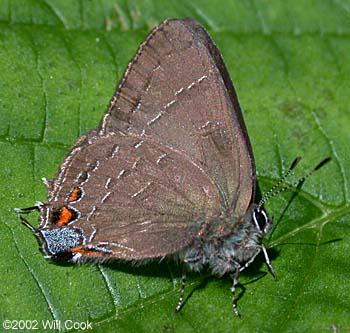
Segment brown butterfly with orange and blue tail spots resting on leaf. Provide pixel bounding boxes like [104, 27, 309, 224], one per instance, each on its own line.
[21, 19, 330, 315]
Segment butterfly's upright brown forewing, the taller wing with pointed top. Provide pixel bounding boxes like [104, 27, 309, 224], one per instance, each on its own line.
[100, 19, 255, 216]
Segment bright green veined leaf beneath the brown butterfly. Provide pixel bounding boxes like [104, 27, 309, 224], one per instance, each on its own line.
[0, 0, 350, 332]
